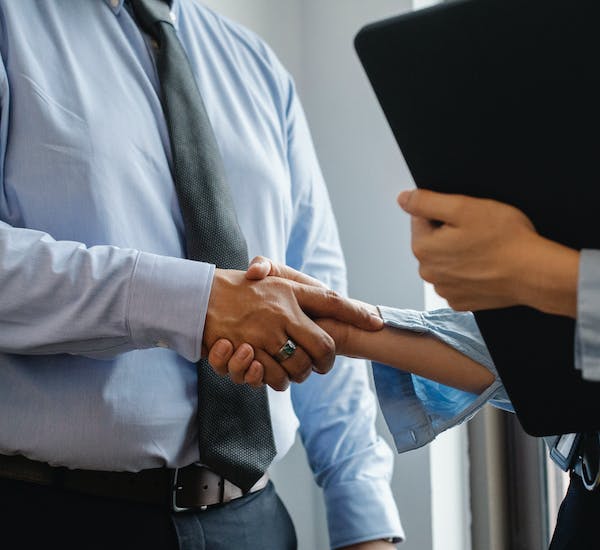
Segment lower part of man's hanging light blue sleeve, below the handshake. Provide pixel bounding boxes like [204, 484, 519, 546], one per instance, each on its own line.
[292, 358, 404, 548]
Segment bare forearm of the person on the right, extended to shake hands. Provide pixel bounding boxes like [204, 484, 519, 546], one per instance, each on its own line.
[344, 327, 494, 393]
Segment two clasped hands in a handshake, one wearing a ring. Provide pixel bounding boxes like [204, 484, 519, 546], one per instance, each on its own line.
[202, 257, 383, 391]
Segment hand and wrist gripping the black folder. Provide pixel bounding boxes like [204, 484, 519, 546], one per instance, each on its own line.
[398, 189, 579, 317]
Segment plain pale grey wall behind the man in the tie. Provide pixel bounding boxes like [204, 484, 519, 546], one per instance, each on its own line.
[200, 0, 432, 550]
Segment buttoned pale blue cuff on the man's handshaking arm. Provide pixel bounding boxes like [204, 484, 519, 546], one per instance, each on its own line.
[127, 252, 215, 362]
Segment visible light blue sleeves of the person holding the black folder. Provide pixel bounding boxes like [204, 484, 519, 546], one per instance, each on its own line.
[373, 250, 600, 452]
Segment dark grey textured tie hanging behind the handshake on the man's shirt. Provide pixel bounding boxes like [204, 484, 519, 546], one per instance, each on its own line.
[130, 0, 275, 491]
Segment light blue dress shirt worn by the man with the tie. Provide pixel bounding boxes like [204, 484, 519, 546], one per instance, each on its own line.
[0, 0, 403, 547]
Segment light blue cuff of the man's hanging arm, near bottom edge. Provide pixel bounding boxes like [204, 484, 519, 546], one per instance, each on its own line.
[325, 479, 405, 548]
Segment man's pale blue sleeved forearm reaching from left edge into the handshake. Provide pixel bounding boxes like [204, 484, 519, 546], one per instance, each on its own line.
[0, 222, 212, 360]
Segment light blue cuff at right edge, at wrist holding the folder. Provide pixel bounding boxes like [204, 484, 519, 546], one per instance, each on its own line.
[575, 250, 600, 382]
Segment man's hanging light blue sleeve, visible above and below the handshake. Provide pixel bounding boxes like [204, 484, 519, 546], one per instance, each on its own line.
[286, 62, 404, 548]
